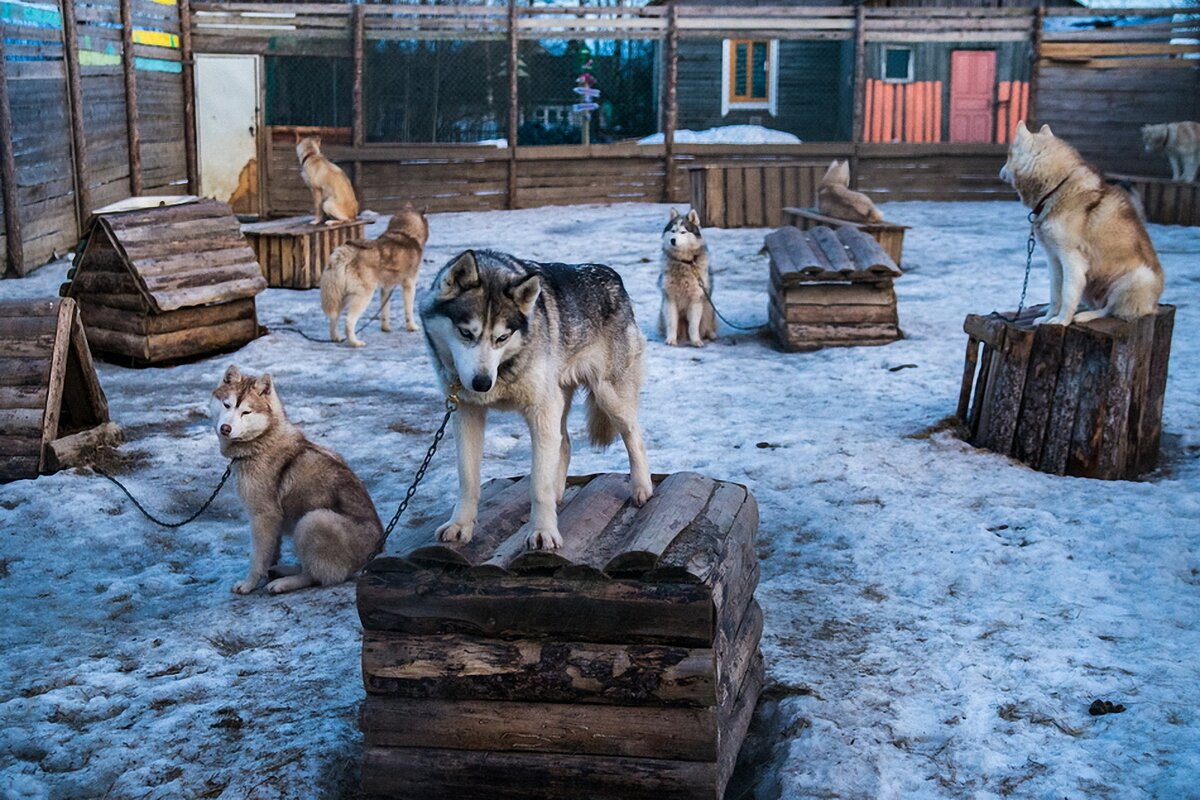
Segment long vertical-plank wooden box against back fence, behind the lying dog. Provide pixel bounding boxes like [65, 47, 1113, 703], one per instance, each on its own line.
[688, 160, 829, 228]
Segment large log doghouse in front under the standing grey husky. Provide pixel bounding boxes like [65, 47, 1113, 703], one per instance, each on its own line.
[358, 473, 763, 800]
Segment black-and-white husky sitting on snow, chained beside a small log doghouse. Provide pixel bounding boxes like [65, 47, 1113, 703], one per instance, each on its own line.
[659, 209, 716, 347]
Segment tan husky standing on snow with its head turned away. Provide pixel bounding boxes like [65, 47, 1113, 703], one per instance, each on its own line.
[320, 204, 430, 347]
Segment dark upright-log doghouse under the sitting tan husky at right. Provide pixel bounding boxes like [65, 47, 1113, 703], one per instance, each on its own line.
[958, 306, 1175, 480]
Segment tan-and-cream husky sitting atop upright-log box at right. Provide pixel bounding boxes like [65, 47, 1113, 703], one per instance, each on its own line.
[1000, 120, 1163, 325]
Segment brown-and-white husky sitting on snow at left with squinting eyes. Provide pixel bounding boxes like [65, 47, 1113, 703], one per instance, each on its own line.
[210, 366, 383, 595]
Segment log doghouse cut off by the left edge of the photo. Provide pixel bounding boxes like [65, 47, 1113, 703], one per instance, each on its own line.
[0, 299, 121, 482]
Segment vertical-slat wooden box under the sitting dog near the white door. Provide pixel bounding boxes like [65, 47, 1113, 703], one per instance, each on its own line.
[241, 215, 367, 289]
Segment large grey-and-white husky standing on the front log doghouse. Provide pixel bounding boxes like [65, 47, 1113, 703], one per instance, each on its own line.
[421, 249, 653, 549]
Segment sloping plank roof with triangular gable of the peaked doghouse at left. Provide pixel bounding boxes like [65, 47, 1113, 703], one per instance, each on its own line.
[61, 199, 266, 314]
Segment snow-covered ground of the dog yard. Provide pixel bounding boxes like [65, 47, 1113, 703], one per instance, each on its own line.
[0, 203, 1200, 800]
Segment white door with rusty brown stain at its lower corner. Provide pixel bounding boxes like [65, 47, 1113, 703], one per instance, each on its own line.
[196, 53, 260, 213]
